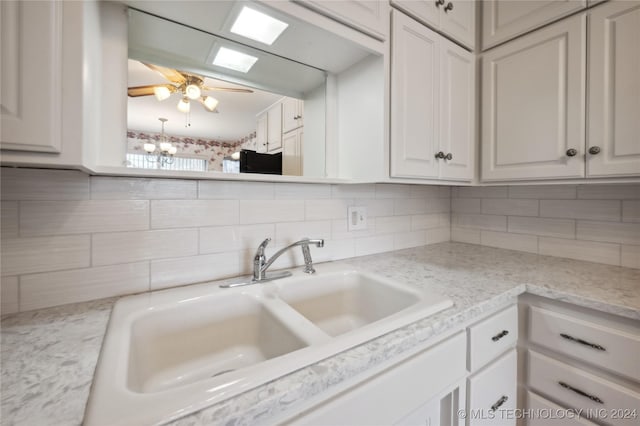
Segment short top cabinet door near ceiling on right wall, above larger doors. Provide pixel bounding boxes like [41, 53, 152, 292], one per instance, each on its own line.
[482, 0, 587, 50]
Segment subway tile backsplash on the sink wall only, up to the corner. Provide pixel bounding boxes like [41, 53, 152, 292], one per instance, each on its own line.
[1, 168, 450, 314]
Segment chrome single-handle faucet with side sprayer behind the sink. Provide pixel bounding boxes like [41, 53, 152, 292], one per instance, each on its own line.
[220, 238, 324, 288]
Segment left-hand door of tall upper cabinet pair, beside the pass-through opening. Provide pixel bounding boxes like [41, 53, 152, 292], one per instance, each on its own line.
[391, 11, 440, 178]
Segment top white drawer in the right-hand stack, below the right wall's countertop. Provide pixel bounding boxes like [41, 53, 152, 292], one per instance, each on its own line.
[529, 306, 640, 381]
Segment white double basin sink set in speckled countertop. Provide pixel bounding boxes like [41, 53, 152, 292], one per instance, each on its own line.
[85, 265, 452, 425]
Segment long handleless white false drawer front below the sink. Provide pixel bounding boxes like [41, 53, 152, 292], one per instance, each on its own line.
[285, 332, 466, 425]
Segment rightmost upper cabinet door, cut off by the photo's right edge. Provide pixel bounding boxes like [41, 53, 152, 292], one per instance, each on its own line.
[586, 1, 640, 177]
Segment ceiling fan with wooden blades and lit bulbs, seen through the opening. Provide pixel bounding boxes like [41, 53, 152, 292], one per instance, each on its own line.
[127, 63, 253, 113]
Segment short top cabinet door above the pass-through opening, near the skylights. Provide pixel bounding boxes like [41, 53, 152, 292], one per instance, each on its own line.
[299, 0, 389, 40]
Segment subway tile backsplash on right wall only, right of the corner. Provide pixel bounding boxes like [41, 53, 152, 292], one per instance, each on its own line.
[451, 184, 640, 268]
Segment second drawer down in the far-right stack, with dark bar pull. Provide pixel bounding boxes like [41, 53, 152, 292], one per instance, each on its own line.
[528, 351, 640, 425]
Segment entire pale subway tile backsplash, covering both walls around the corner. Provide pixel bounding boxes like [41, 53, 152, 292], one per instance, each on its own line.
[1, 168, 640, 314]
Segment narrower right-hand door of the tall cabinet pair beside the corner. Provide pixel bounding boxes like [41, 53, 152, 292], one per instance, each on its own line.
[438, 39, 476, 180]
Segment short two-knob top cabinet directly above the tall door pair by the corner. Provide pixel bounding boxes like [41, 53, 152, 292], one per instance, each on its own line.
[391, 0, 476, 50]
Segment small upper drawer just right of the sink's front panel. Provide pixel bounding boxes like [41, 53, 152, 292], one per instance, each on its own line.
[469, 306, 518, 372]
